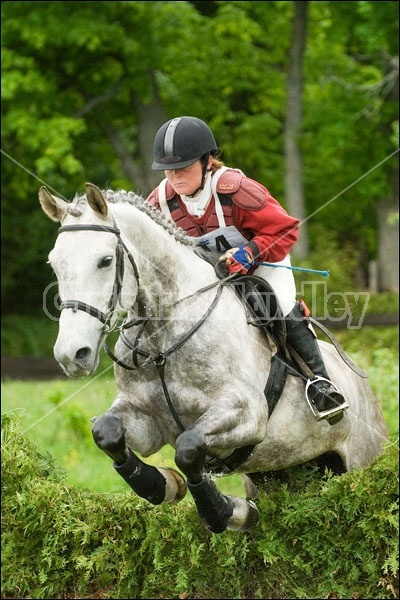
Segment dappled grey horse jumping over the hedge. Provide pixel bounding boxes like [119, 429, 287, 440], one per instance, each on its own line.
[39, 183, 388, 533]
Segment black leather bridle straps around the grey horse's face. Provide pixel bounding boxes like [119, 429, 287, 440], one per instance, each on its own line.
[58, 221, 139, 333]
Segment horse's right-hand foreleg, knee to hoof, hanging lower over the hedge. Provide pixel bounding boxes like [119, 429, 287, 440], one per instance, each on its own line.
[175, 430, 259, 533]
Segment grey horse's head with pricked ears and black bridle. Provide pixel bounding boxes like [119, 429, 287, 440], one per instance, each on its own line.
[39, 183, 139, 377]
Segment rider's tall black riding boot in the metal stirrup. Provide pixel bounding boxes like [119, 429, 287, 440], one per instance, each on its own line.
[285, 302, 349, 425]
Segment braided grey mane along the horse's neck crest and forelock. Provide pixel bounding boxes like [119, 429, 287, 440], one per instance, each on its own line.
[67, 185, 194, 247]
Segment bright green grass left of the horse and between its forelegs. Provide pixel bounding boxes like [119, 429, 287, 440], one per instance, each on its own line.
[2, 371, 247, 495]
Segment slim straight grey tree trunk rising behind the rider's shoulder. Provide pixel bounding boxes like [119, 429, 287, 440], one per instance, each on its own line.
[284, 0, 308, 258]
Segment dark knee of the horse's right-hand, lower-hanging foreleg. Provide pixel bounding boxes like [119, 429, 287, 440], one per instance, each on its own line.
[175, 430, 207, 483]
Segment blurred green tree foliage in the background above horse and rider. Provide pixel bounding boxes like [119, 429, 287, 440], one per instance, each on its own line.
[1, 0, 398, 314]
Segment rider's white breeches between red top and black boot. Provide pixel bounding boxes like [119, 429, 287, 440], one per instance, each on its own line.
[253, 256, 296, 316]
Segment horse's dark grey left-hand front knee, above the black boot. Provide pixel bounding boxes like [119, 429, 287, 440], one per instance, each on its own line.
[92, 413, 129, 464]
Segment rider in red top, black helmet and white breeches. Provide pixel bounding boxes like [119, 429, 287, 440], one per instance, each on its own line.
[147, 116, 347, 425]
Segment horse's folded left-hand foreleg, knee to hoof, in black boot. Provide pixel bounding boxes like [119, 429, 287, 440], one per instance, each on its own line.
[92, 413, 186, 504]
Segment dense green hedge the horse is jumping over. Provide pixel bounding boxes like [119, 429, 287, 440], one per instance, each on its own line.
[2, 412, 398, 599]
